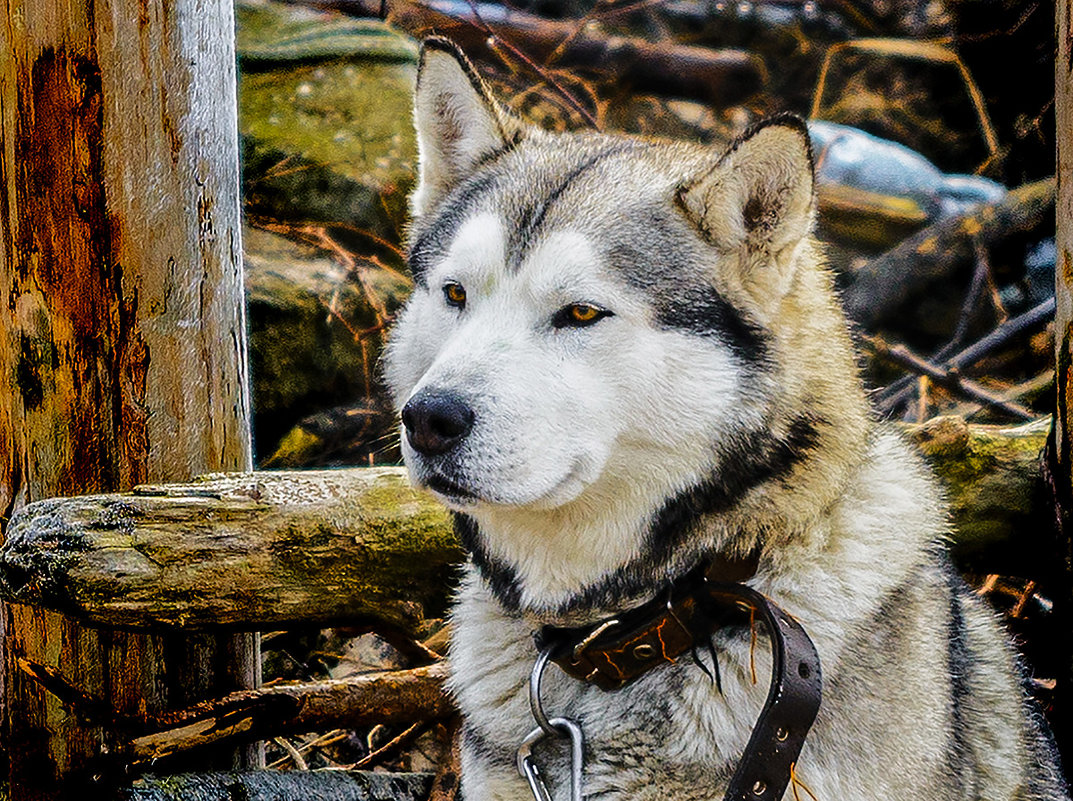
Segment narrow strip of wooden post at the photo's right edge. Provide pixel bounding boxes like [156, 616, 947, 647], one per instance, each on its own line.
[1047, 0, 1073, 766]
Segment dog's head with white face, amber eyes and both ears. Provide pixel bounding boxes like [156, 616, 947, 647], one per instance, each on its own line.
[386, 40, 852, 609]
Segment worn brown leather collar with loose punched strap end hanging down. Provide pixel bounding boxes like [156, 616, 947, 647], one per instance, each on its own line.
[538, 557, 821, 801]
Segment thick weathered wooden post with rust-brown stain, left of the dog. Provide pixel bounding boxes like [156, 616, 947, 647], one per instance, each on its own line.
[0, 0, 258, 799]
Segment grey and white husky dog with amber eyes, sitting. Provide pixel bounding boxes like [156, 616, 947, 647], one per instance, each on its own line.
[385, 40, 1068, 801]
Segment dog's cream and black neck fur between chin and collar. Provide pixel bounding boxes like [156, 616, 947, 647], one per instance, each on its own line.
[455, 420, 863, 626]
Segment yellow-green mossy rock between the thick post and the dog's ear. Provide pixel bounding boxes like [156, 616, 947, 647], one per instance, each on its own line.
[236, 0, 417, 234]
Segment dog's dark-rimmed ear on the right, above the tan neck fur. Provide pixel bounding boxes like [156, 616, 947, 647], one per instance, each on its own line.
[678, 115, 813, 262]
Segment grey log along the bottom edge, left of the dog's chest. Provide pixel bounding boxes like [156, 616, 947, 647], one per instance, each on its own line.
[115, 770, 432, 801]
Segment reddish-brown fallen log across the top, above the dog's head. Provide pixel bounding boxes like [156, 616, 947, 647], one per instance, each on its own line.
[276, 0, 765, 106]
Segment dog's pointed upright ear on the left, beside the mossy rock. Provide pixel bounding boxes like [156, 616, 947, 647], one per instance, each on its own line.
[410, 36, 521, 218]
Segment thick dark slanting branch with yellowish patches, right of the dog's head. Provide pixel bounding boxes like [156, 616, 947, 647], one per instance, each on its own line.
[842, 177, 1056, 328]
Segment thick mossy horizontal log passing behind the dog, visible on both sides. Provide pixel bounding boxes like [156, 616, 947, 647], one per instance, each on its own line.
[0, 418, 1047, 631]
